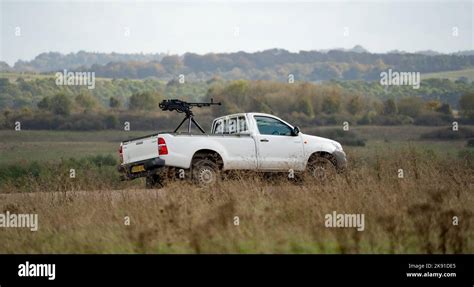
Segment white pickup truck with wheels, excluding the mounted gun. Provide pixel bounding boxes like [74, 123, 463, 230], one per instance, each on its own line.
[119, 113, 347, 187]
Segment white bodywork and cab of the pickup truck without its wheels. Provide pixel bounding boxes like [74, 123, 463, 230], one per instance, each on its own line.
[120, 113, 346, 179]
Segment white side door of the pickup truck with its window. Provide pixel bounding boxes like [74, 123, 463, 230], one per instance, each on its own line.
[254, 116, 303, 171]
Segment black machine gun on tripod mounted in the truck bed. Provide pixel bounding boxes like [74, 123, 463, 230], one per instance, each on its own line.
[159, 99, 221, 134]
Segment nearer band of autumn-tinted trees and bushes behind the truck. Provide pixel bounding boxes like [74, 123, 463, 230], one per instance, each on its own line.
[0, 80, 474, 130]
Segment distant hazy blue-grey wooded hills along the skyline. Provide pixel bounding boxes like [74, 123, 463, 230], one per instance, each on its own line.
[0, 49, 474, 82]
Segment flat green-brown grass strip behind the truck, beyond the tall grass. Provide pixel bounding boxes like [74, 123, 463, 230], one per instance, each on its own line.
[0, 126, 465, 166]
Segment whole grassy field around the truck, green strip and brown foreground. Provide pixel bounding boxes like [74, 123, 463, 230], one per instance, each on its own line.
[0, 126, 474, 253]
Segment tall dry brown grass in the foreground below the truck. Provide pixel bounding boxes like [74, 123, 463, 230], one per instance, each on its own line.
[0, 147, 474, 253]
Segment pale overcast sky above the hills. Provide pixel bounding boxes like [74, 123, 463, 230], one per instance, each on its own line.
[0, 0, 474, 65]
